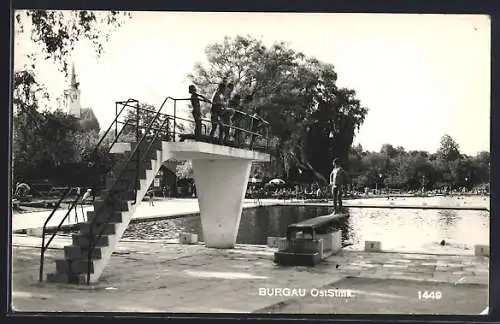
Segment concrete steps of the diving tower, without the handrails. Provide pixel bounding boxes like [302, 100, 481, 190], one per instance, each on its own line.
[47, 138, 166, 283]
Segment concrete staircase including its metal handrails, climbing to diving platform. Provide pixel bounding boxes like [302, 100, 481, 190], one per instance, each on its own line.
[39, 97, 269, 284]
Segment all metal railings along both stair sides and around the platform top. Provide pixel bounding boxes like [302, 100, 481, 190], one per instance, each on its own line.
[40, 97, 270, 284]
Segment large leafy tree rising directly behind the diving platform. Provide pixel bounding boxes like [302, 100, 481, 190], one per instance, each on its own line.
[189, 36, 368, 184]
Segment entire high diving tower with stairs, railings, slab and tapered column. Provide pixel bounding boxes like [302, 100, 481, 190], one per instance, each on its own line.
[39, 97, 270, 284]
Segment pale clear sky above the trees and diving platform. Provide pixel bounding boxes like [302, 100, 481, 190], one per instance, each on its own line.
[14, 12, 490, 155]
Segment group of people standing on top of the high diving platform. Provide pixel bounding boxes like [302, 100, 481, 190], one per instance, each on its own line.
[189, 81, 267, 146]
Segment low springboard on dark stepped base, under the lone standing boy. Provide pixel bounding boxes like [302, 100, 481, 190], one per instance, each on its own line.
[274, 214, 348, 266]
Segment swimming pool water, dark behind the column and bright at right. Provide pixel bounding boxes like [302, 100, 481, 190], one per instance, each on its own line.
[124, 197, 489, 250]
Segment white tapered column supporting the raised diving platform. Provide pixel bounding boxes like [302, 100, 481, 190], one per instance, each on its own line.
[192, 159, 252, 249]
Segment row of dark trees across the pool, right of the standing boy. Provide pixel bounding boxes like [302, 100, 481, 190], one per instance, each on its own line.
[349, 135, 490, 190]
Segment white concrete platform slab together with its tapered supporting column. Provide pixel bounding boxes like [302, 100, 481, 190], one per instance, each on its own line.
[163, 142, 270, 249]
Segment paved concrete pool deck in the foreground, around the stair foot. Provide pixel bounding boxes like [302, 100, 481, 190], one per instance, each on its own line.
[12, 234, 489, 315]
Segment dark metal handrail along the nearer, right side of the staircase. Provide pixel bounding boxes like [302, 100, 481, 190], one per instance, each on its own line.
[87, 97, 173, 284]
